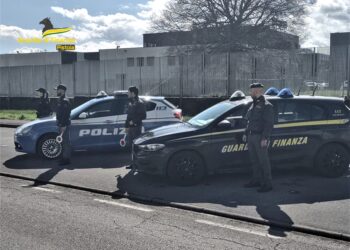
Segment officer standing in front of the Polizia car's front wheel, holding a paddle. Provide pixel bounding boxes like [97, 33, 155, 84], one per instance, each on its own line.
[55, 84, 71, 165]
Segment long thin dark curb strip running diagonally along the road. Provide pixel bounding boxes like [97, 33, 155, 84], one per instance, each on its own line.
[0, 172, 350, 242]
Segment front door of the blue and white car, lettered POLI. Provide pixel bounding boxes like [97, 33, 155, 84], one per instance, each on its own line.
[70, 99, 119, 149]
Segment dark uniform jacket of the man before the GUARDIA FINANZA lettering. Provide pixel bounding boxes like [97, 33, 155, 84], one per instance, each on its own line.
[246, 96, 274, 138]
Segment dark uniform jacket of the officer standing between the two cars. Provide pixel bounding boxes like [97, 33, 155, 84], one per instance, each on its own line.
[125, 98, 146, 128]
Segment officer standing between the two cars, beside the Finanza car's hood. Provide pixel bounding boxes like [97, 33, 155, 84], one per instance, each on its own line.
[125, 86, 146, 146]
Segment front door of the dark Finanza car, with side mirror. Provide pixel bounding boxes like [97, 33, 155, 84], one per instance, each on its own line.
[210, 105, 249, 172]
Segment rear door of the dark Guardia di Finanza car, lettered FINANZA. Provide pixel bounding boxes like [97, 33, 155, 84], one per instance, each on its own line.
[270, 99, 327, 164]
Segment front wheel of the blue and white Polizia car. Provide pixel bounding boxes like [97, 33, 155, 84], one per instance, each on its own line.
[37, 134, 62, 160]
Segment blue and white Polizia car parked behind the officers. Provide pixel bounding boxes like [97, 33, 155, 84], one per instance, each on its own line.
[14, 91, 182, 159]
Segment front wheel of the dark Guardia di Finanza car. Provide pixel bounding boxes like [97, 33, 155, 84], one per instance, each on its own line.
[167, 151, 206, 186]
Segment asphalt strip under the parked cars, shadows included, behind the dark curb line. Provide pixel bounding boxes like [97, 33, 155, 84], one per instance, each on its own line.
[0, 128, 350, 238]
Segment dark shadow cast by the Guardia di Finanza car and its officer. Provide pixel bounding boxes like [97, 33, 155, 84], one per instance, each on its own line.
[116, 169, 350, 237]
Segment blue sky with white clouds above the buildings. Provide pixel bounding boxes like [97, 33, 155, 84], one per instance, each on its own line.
[0, 0, 350, 54]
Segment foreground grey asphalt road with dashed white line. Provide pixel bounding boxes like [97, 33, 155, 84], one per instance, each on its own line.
[0, 177, 350, 250]
